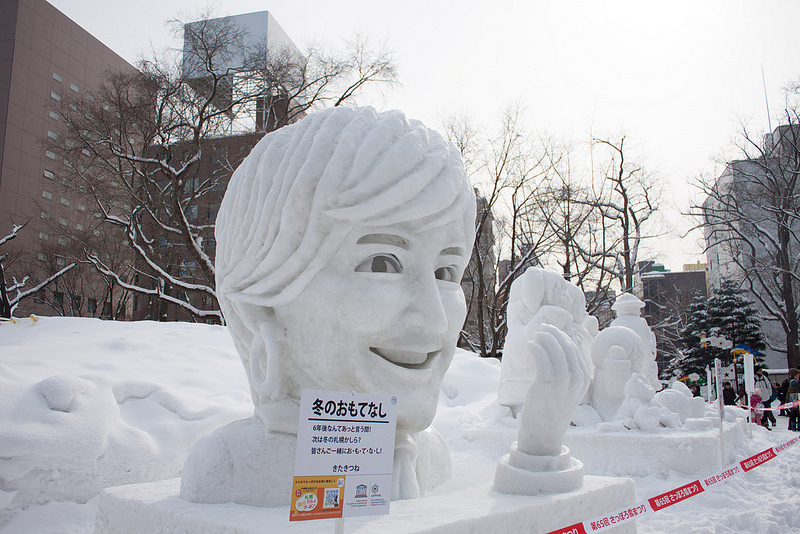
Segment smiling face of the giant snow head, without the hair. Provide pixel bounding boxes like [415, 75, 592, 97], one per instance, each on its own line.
[275, 224, 469, 433]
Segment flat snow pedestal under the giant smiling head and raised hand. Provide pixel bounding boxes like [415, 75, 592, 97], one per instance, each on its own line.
[95, 476, 636, 534]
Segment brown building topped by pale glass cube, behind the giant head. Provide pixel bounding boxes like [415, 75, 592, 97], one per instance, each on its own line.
[133, 11, 304, 322]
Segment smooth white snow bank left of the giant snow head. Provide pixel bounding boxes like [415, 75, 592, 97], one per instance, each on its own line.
[0, 318, 252, 515]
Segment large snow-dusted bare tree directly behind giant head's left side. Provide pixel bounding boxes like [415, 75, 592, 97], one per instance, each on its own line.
[49, 13, 395, 321]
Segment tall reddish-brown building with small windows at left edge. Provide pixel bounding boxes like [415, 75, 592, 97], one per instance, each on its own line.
[0, 0, 133, 315]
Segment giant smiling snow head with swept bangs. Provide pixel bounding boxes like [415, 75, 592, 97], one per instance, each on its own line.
[216, 108, 475, 438]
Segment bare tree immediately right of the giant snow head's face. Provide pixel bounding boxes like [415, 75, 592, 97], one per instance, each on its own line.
[444, 105, 544, 357]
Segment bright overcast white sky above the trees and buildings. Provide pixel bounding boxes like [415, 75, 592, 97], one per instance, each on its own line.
[48, 0, 800, 270]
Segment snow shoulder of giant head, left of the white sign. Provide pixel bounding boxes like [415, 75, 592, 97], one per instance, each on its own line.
[180, 417, 297, 507]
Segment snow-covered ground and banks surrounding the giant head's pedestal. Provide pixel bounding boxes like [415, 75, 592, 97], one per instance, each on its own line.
[0, 318, 800, 534]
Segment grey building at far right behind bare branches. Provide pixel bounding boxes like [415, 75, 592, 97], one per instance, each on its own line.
[702, 124, 800, 369]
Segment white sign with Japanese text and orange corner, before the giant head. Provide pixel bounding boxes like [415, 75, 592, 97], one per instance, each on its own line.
[289, 390, 397, 521]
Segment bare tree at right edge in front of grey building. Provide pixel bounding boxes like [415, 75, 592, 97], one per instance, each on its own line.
[692, 103, 800, 367]
